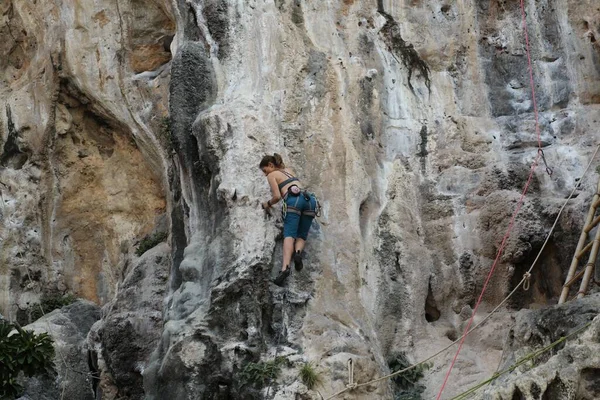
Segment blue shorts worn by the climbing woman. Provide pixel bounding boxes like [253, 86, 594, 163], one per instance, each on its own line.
[283, 193, 317, 240]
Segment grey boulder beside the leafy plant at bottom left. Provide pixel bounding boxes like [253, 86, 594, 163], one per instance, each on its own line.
[19, 300, 101, 400]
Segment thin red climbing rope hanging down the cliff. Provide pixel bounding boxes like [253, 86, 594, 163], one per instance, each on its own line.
[436, 0, 552, 400]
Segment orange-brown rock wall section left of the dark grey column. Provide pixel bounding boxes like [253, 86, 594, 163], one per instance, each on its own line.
[0, 0, 174, 318]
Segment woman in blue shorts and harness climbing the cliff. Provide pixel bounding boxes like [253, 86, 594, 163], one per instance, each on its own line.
[259, 153, 318, 286]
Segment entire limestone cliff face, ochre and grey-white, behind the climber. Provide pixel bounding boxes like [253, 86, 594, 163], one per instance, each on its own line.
[0, 0, 600, 399]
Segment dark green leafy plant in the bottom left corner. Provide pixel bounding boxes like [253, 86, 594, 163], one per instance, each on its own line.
[0, 320, 54, 399]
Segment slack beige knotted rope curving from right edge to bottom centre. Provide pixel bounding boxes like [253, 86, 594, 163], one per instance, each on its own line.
[326, 145, 600, 400]
